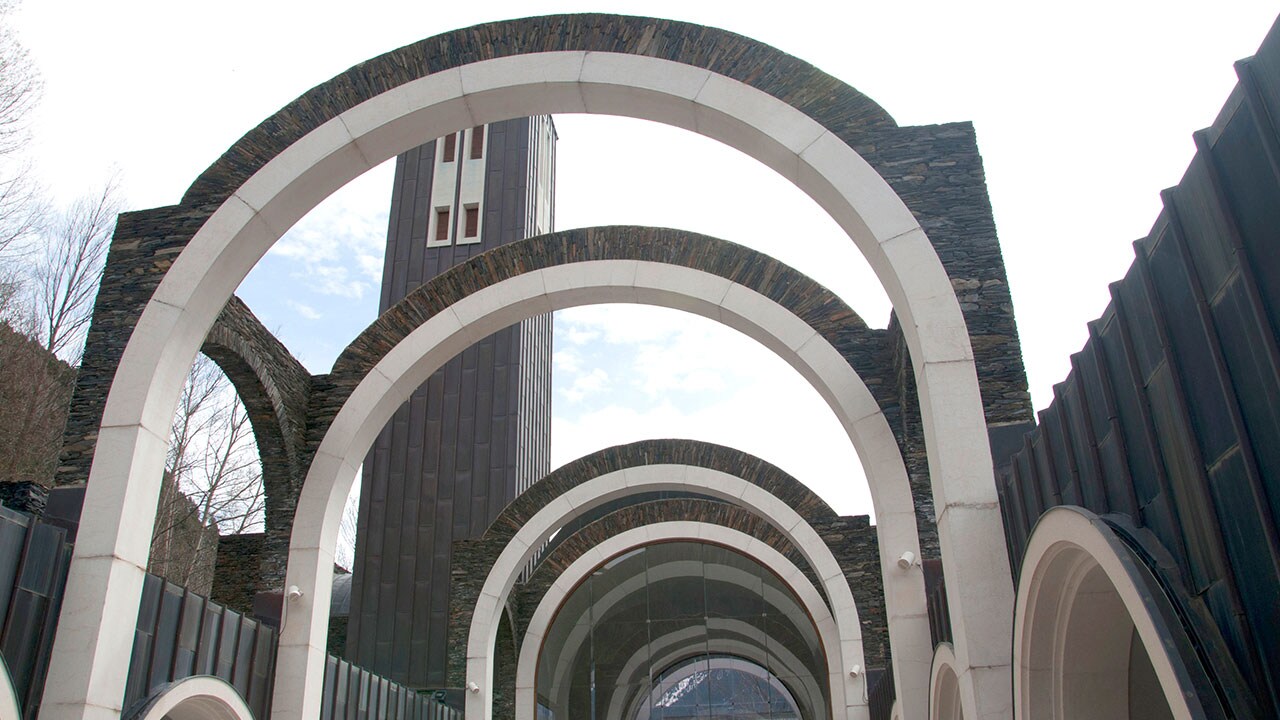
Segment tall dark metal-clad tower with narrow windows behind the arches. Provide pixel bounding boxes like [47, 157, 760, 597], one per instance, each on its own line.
[346, 117, 556, 688]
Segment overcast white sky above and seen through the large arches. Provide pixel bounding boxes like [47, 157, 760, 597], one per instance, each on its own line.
[17, 0, 1277, 512]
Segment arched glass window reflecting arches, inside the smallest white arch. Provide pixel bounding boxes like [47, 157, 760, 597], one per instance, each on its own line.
[538, 542, 829, 720]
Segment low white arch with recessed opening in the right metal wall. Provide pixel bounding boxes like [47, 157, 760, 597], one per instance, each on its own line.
[1014, 506, 1206, 719]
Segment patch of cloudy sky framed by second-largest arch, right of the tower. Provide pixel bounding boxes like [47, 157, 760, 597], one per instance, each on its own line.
[552, 306, 872, 514]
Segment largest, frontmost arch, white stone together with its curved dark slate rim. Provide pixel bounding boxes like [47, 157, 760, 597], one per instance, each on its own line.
[45, 15, 1012, 716]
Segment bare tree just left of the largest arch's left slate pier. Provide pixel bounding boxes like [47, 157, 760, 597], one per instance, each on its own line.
[31, 178, 120, 365]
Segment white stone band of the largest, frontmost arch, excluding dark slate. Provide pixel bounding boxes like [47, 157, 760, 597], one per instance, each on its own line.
[44, 40, 1012, 720]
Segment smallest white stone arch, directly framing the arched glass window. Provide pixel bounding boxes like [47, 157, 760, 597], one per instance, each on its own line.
[514, 520, 869, 720]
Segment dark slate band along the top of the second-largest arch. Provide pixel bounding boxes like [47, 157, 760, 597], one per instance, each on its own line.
[322, 225, 890, 453]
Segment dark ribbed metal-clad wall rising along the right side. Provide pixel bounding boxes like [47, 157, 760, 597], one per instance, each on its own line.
[1001, 15, 1280, 717]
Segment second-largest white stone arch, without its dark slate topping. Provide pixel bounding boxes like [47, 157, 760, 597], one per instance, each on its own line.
[273, 260, 932, 717]
